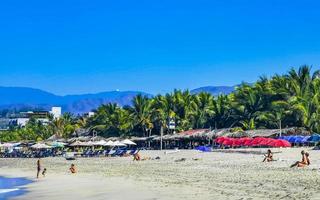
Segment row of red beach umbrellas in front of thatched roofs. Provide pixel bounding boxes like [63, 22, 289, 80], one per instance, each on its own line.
[215, 137, 291, 147]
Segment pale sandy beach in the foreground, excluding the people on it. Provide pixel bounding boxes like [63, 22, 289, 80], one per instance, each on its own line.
[0, 148, 320, 200]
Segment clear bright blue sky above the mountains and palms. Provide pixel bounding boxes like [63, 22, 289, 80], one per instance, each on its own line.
[0, 0, 320, 94]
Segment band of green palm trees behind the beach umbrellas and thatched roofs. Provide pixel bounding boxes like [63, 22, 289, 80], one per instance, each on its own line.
[0, 66, 320, 141]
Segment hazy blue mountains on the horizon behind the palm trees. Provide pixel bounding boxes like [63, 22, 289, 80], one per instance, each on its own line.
[0, 86, 234, 114]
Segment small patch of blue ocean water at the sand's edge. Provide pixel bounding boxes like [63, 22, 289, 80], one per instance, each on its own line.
[0, 176, 32, 200]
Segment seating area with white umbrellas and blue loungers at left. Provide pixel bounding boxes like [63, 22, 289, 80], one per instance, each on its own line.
[0, 138, 137, 158]
